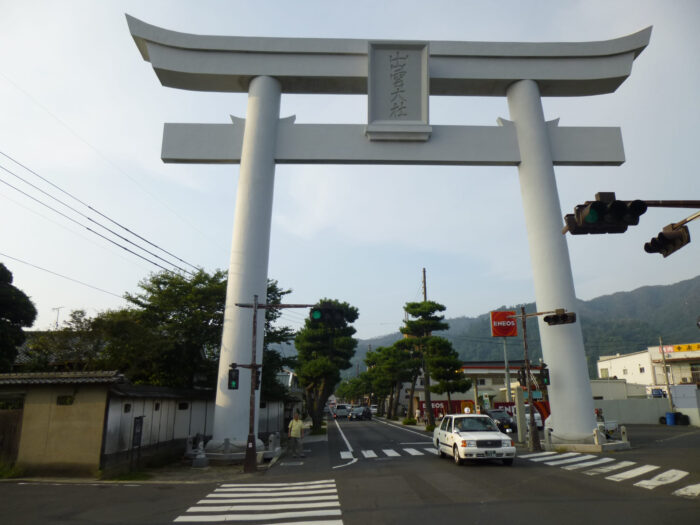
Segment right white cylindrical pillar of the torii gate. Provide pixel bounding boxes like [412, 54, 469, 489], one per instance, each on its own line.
[507, 80, 594, 441]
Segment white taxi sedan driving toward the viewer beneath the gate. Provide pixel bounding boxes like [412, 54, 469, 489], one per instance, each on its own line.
[433, 414, 515, 465]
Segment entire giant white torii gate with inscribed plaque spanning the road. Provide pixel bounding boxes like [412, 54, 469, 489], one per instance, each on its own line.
[127, 15, 651, 444]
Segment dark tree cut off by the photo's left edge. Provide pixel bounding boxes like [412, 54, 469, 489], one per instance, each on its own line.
[0, 263, 36, 372]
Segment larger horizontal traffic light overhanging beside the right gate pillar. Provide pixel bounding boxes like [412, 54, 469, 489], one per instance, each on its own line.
[564, 192, 647, 235]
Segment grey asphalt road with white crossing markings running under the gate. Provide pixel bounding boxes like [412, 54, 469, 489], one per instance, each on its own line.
[0, 419, 700, 525]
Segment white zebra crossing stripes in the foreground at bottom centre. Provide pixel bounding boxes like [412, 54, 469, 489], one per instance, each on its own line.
[174, 479, 343, 525]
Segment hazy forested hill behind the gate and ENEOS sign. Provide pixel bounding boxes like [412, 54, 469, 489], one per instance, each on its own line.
[344, 276, 700, 377]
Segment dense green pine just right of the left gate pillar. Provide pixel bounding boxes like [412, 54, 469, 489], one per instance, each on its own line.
[294, 299, 358, 432]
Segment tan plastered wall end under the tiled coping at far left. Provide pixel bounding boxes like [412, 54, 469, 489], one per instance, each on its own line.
[17, 385, 107, 474]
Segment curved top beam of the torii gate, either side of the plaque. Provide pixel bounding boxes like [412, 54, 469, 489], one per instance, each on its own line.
[126, 15, 651, 97]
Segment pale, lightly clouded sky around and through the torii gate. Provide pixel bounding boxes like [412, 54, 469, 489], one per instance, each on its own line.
[0, 0, 700, 339]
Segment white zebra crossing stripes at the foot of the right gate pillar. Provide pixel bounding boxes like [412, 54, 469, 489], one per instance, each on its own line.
[518, 452, 700, 498]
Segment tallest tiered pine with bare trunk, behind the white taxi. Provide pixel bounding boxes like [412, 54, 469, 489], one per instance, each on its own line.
[400, 301, 449, 427]
